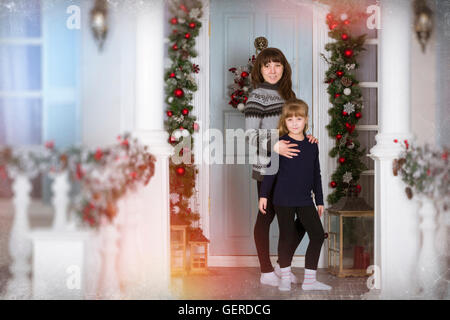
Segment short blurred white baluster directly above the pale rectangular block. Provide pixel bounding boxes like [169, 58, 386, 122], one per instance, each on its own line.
[52, 171, 70, 230]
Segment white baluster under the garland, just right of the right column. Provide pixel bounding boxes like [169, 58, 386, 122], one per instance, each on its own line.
[417, 196, 440, 299]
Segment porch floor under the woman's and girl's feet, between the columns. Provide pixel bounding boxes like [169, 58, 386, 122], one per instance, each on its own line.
[172, 267, 371, 300]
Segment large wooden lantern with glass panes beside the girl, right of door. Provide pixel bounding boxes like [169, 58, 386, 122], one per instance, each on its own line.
[327, 187, 374, 277]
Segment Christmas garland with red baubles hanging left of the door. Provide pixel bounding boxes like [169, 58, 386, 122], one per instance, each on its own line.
[164, 0, 202, 238]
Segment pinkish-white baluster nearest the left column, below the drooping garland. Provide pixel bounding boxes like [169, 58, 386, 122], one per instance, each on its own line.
[98, 219, 121, 300]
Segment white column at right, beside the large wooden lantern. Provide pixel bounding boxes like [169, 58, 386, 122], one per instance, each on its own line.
[371, 0, 419, 299]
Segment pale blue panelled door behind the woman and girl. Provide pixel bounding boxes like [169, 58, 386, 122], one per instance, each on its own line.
[210, 0, 312, 256]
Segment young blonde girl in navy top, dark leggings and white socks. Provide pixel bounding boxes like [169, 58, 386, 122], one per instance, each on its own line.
[259, 100, 331, 291]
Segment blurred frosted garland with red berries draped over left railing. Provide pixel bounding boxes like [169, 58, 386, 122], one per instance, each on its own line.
[0, 134, 155, 227]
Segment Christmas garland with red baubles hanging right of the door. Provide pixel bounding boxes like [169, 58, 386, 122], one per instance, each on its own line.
[321, 2, 367, 204]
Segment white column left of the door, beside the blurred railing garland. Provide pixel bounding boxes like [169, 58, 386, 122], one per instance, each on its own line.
[133, 0, 172, 299]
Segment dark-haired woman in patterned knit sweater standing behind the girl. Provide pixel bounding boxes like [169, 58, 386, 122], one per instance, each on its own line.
[244, 48, 317, 286]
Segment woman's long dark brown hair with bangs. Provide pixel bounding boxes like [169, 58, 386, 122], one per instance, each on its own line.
[252, 48, 296, 101]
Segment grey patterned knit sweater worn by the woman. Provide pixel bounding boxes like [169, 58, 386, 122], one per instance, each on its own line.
[244, 82, 285, 181]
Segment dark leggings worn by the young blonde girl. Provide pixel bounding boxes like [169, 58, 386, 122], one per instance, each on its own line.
[275, 206, 324, 270]
